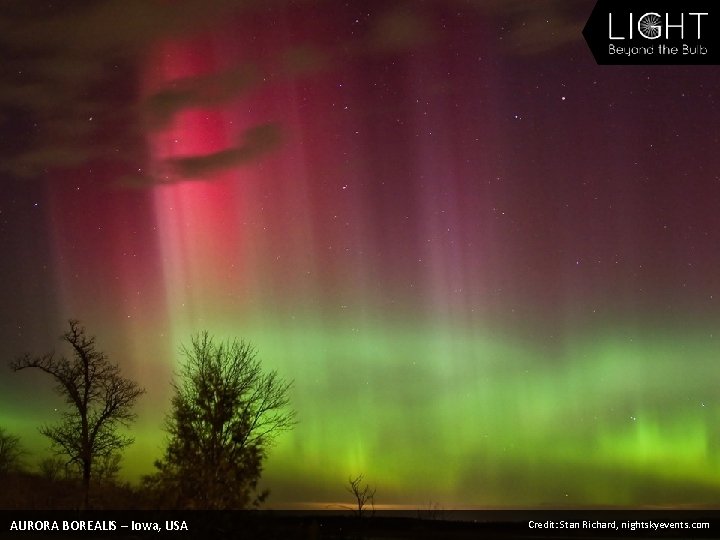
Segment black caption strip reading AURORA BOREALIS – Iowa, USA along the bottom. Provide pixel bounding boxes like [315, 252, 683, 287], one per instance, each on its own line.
[0, 510, 720, 540]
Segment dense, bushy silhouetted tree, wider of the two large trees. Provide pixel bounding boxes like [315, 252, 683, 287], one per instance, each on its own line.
[146, 332, 295, 509]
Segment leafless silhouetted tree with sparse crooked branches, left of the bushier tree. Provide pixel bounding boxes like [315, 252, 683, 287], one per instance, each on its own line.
[11, 320, 145, 507]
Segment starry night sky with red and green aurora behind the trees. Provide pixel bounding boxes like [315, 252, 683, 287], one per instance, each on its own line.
[0, 0, 720, 508]
